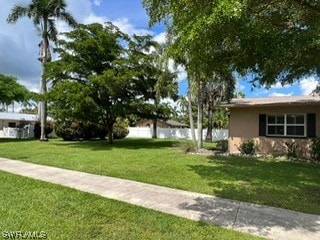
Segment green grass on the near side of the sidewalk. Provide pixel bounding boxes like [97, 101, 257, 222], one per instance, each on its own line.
[0, 171, 260, 240]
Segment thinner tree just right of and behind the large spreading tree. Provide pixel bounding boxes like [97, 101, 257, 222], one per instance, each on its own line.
[129, 35, 178, 138]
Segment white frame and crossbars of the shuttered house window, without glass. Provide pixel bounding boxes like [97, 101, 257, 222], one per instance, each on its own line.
[266, 113, 307, 138]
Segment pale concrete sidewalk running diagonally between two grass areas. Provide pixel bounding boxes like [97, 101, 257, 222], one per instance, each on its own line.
[0, 158, 320, 240]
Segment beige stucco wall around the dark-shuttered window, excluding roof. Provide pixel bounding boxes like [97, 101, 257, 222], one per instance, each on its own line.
[229, 105, 320, 154]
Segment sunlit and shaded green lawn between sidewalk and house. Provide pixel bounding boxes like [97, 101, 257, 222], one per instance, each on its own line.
[0, 139, 320, 214]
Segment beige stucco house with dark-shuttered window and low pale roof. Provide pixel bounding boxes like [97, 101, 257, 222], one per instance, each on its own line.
[221, 96, 320, 154]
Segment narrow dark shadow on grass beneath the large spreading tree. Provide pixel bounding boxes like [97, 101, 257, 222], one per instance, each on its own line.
[53, 139, 177, 151]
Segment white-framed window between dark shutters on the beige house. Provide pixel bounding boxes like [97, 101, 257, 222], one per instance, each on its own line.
[267, 114, 306, 137]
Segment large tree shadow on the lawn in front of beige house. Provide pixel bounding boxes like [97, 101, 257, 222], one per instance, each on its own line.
[189, 156, 320, 214]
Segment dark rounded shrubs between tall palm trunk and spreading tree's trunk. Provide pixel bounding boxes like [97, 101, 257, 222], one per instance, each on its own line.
[55, 121, 107, 141]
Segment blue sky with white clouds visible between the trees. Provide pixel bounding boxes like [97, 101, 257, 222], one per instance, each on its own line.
[0, 0, 319, 97]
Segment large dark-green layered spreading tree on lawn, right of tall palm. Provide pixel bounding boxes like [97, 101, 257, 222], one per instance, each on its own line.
[47, 23, 142, 144]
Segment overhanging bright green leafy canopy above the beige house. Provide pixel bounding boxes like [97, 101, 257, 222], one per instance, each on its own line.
[143, 0, 320, 85]
